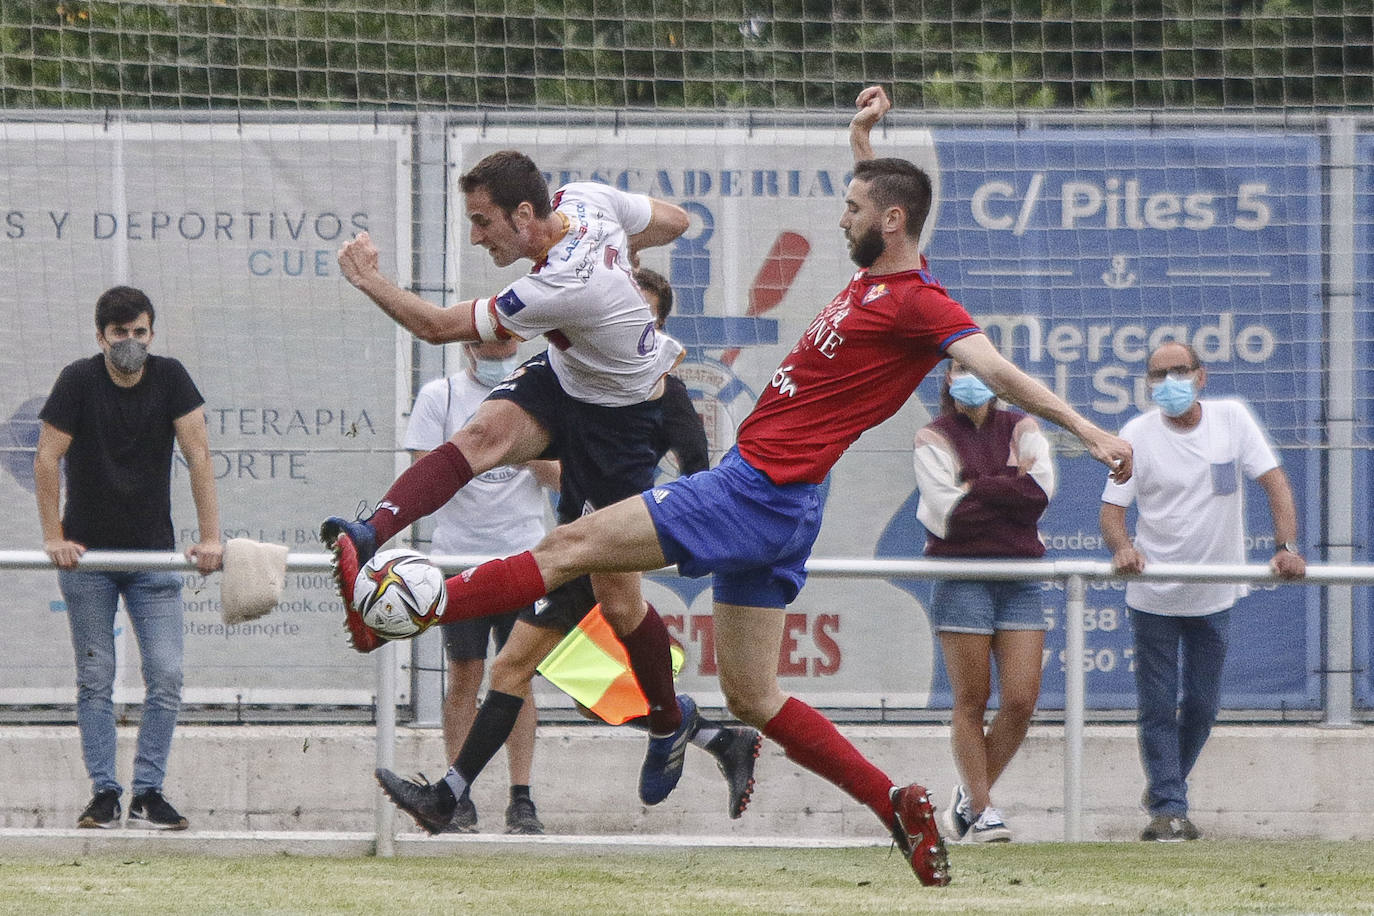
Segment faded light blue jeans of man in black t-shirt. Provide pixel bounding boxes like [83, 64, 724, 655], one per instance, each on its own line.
[58, 570, 183, 795]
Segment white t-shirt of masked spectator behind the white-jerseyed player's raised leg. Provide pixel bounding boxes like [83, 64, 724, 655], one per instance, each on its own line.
[404, 372, 548, 556]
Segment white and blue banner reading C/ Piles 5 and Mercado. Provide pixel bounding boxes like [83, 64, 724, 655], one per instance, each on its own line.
[451, 128, 1320, 709]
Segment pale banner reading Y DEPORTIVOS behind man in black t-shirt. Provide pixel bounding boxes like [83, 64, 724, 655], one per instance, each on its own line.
[0, 119, 411, 705]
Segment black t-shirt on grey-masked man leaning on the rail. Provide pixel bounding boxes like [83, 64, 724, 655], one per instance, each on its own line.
[38, 354, 205, 551]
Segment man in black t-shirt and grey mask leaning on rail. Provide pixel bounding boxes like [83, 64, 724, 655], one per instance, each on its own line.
[33, 286, 224, 829]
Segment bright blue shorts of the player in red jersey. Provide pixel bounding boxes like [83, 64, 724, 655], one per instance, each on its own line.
[643, 448, 823, 607]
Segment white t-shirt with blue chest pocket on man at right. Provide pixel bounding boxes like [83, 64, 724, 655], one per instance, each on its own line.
[1102, 400, 1279, 617]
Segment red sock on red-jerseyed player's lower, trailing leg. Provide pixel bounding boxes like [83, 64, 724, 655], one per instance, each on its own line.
[764, 696, 893, 829]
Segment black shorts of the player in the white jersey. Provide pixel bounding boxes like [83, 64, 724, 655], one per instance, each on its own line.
[488, 353, 664, 521]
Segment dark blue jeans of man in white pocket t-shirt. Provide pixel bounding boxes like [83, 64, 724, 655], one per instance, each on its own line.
[1131, 608, 1231, 817]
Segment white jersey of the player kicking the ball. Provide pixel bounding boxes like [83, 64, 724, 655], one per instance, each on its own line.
[474, 181, 683, 407]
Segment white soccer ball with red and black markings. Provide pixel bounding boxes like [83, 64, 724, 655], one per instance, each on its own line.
[353, 549, 448, 640]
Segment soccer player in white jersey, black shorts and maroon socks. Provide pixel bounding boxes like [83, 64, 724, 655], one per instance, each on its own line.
[320, 150, 697, 805]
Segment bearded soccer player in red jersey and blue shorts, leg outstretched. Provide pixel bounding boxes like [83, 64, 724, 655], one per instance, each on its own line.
[340, 87, 1131, 884]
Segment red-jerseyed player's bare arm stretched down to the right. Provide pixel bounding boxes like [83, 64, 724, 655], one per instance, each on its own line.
[948, 334, 1131, 483]
